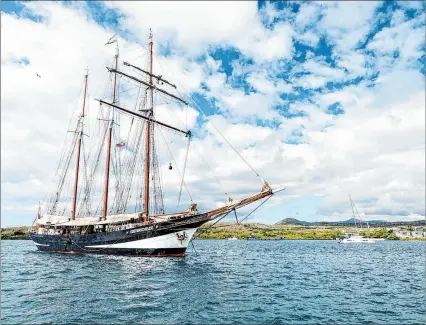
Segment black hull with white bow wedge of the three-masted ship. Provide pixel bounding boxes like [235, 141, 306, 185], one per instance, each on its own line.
[29, 214, 209, 256]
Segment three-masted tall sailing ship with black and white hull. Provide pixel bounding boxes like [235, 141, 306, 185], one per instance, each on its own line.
[29, 33, 278, 256]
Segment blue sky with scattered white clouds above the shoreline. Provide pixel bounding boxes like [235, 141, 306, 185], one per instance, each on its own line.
[1, 1, 426, 227]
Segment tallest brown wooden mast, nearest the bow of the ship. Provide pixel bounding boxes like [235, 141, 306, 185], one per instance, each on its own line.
[143, 30, 154, 217]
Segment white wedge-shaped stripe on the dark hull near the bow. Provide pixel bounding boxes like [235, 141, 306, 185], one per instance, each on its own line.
[85, 228, 197, 249]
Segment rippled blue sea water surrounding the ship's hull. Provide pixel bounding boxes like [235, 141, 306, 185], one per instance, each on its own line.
[1, 240, 426, 324]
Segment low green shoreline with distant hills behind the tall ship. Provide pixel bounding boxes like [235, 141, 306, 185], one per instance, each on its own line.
[1, 218, 426, 240]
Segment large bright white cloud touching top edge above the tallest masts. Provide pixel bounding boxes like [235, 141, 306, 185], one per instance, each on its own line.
[108, 1, 292, 61]
